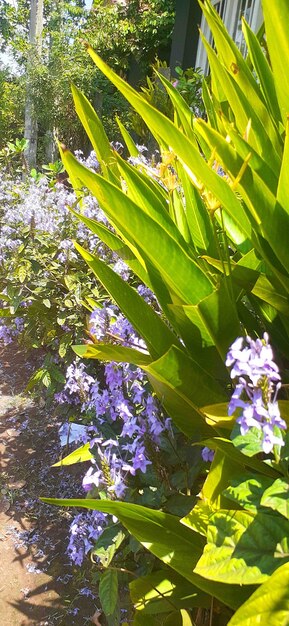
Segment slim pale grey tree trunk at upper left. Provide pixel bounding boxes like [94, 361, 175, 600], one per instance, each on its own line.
[24, 0, 43, 169]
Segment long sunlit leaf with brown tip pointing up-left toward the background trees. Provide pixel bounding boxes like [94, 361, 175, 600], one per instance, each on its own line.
[88, 48, 251, 237]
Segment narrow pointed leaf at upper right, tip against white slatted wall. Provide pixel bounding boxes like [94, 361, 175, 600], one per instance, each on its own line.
[243, 20, 281, 122]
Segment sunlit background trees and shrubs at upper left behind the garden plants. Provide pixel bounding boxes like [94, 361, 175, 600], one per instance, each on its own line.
[0, 0, 174, 158]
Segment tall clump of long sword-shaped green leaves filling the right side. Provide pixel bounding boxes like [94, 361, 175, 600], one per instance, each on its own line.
[47, 0, 289, 626]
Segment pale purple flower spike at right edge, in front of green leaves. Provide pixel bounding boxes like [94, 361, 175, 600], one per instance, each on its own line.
[226, 333, 286, 454]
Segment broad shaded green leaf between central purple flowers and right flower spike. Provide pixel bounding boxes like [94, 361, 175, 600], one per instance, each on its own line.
[143, 346, 224, 438]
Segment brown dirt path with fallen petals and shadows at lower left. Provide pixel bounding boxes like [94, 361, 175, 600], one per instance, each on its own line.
[0, 346, 95, 626]
